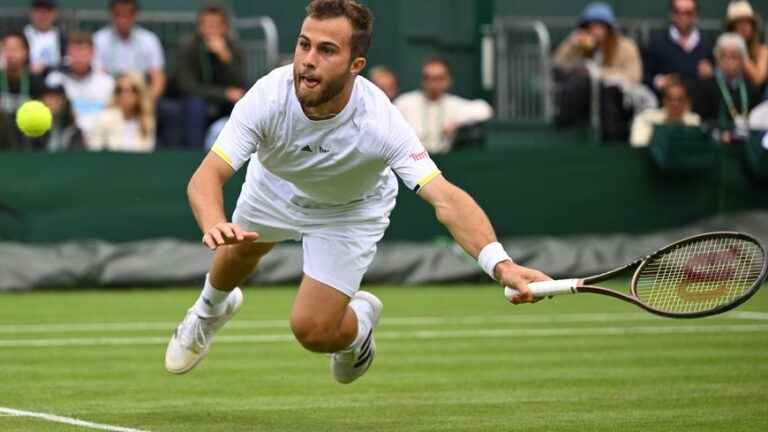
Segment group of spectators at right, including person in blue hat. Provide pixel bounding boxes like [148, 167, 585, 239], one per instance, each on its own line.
[553, 0, 768, 146]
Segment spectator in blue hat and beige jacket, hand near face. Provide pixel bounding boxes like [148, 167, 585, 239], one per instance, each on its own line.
[554, 2, 643, 83]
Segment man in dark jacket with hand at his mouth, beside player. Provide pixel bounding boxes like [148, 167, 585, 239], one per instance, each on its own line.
[176, 6, 246, 148]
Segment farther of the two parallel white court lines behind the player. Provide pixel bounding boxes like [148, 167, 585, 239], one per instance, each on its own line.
[0, 311, 768, 334]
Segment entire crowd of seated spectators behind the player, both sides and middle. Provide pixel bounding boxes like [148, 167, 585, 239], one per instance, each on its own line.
[0, 0, 768, 154]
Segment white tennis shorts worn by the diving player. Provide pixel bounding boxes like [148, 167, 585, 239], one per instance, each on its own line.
[232, 181, 394, 297]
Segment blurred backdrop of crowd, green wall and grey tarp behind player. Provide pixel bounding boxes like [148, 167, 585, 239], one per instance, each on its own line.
[0, 0, 768, 290]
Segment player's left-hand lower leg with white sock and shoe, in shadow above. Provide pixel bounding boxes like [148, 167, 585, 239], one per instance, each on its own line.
[165, 243, 274, 374]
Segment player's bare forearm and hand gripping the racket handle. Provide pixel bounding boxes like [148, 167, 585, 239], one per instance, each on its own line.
[419, 176, 551, 304]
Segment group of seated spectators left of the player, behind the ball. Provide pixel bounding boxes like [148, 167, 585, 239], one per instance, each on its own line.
[0, 0, 246, 152]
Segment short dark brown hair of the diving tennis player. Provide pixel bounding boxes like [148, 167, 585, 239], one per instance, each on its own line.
[307, 0, 373, 58]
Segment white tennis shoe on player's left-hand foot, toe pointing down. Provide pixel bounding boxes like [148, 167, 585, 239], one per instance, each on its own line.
[165, 288, 243, 374]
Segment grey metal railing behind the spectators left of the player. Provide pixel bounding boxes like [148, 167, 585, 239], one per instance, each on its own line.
[0, 8, 280, 82]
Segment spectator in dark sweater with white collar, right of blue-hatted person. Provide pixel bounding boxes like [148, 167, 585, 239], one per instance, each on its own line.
[643, 0, 714, 92]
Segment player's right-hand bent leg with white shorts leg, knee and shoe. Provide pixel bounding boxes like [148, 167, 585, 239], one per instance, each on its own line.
[291, 218, 388, 383]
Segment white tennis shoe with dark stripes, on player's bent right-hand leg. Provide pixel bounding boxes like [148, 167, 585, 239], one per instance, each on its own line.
[331, 291, 384, 384]
